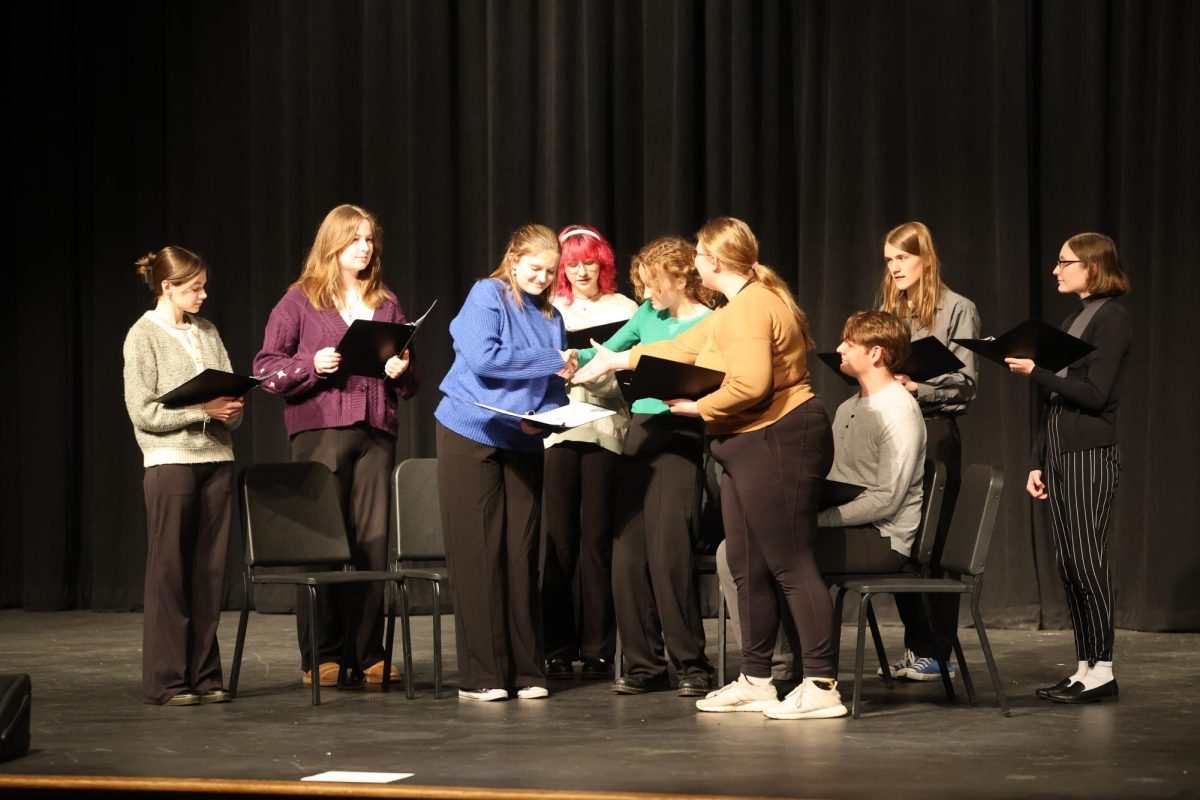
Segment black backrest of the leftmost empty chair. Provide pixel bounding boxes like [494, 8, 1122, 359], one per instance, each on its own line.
[238, 462, 350, 566]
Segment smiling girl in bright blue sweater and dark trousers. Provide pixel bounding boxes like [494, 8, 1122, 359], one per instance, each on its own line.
[434, 225, 576, 700]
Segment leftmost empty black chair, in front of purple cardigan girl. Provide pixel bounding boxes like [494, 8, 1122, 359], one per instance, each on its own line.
[229, 462, 402, 705]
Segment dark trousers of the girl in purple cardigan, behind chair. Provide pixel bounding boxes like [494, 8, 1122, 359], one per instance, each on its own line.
[292, 426, 396, 672]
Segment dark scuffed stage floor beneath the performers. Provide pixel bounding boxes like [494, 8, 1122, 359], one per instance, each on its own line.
[0, 610, 1200, 798]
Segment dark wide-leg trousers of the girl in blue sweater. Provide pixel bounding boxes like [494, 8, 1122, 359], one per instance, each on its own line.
[437, 422, 546, 688]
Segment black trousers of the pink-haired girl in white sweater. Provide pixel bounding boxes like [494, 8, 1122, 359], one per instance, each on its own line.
[541, 441, 620, 662]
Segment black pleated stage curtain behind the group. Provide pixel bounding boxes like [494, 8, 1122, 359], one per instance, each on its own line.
[0, 0, 1200, 630]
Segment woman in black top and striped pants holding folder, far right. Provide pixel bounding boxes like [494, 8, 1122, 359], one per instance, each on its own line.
[1004, 233, 1133, 703]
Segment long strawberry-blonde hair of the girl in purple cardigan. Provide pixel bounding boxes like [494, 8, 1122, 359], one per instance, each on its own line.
[292, 204, 395, 308]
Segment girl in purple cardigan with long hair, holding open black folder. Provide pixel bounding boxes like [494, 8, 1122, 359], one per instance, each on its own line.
[254, 205, 418, 686]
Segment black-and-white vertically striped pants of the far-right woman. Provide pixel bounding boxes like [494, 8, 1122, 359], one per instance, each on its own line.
[1043, 405, 1121, 664]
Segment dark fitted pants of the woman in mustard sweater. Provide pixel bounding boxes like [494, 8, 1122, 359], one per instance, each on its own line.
[710, 397, 836, 678]
